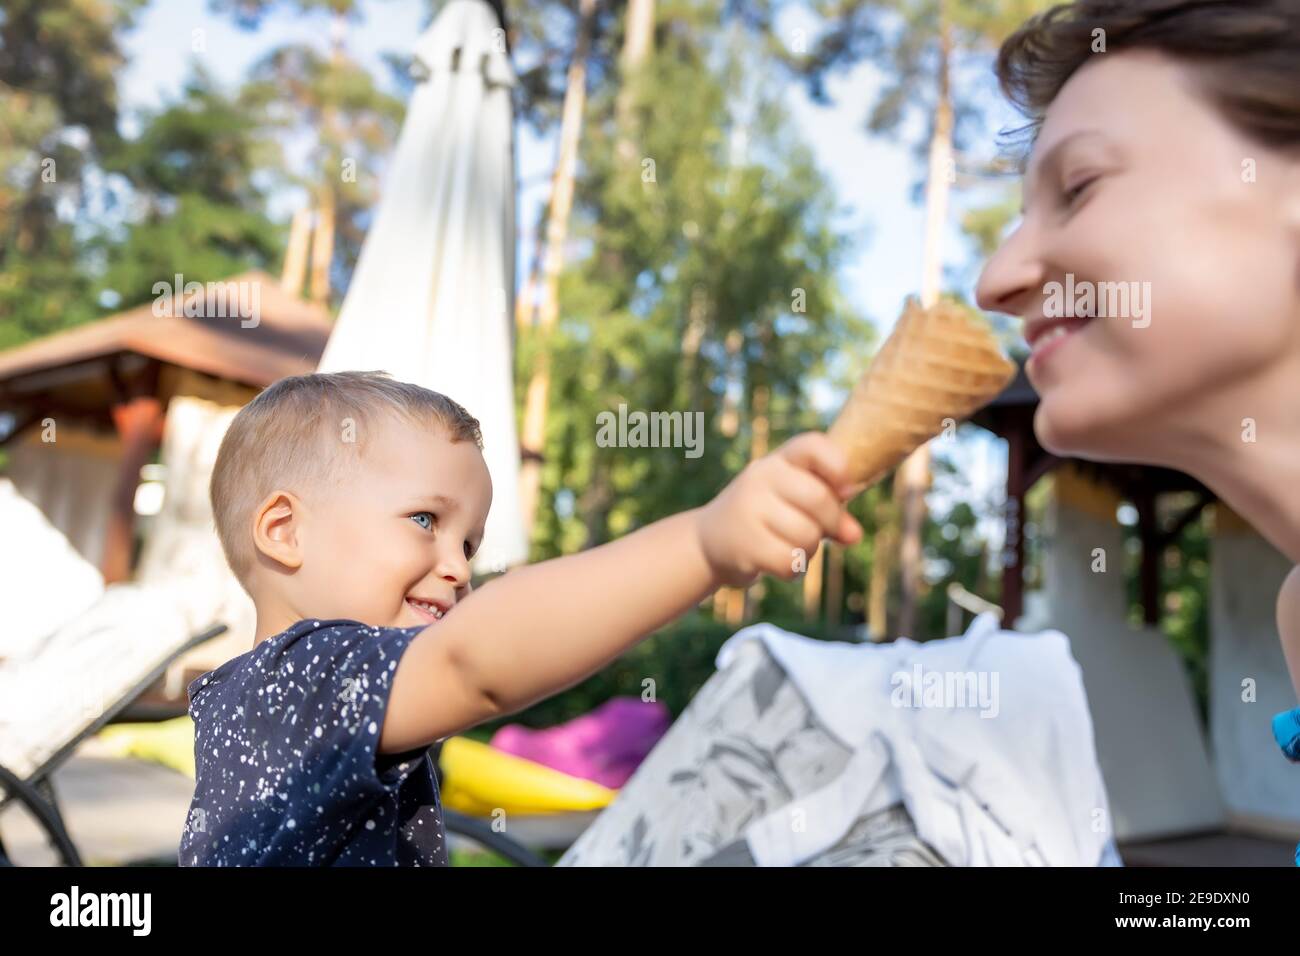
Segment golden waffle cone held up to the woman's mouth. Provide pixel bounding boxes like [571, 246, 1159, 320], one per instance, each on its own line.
[829, 298, 1015, 483]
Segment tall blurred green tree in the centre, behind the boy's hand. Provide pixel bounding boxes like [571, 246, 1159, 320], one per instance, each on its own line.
[517, 4, 871, 567]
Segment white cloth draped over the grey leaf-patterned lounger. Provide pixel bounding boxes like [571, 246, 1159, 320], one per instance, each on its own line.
[718, 614, 1118, 866]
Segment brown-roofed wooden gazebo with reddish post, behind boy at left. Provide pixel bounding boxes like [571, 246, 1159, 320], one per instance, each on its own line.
[0, 272, 330, 583]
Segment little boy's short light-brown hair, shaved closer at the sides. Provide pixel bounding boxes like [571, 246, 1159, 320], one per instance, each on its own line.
[209, 372, 484, 583]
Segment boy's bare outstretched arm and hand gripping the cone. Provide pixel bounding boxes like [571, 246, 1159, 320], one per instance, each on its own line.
[380, 432, 862, 753]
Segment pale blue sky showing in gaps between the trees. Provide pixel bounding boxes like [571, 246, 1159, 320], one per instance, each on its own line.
[121, 0, 1014, 538]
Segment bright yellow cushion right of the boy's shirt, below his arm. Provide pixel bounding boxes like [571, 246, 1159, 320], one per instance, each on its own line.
[438, 737, 618, 817]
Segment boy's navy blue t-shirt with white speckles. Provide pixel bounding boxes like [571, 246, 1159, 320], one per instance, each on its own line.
[178, 620, 447, 866]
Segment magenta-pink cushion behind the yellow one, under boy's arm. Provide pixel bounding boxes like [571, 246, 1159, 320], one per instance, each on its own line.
[491, 697, 672, 790]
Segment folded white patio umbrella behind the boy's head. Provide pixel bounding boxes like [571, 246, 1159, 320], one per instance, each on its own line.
[320, 0, 527, 571]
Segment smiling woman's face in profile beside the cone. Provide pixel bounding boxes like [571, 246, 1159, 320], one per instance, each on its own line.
[976, 51, 1300, 463]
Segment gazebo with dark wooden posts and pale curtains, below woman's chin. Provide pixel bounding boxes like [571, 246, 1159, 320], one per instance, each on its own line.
[974, 365, 1300, 866]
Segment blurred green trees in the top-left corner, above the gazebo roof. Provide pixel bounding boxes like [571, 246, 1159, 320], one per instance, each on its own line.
[0, 12, 283, 335]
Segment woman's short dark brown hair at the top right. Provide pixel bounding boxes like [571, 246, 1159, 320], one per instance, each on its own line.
[996, 0, 1300, 148]
